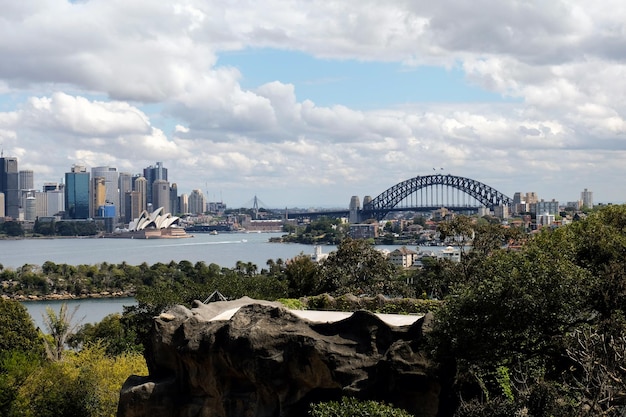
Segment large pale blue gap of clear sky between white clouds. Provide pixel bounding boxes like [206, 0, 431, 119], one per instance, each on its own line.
[218, 49, 512, 110]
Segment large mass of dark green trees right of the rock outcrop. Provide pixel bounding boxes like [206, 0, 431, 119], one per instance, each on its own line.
[432, 206, 626, 416]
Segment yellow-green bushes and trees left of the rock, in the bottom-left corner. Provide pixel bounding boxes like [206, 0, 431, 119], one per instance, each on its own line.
[0, 299, 147, 417]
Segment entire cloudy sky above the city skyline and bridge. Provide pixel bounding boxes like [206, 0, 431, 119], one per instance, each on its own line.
[0, 0, 626, 207]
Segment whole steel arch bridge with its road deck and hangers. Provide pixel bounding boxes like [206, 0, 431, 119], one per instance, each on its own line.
[361, 174, 512, 221]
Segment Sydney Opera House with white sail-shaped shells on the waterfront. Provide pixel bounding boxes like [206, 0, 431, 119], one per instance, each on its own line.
[119, 207, 188, 239]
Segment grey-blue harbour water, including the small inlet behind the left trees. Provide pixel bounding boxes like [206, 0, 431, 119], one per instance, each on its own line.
[6, 233, 439, 328]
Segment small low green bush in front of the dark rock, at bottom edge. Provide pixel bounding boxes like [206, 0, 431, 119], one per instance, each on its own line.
[309, 397, 411, 417]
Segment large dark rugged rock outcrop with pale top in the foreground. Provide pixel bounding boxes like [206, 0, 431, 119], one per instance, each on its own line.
[118, 298, 440, 417]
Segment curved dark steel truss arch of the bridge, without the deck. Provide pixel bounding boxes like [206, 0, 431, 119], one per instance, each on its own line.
[362, 174, 513, 221]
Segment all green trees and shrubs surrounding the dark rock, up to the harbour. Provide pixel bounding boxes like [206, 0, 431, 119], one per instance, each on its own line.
[0, 206, 626, 417]
